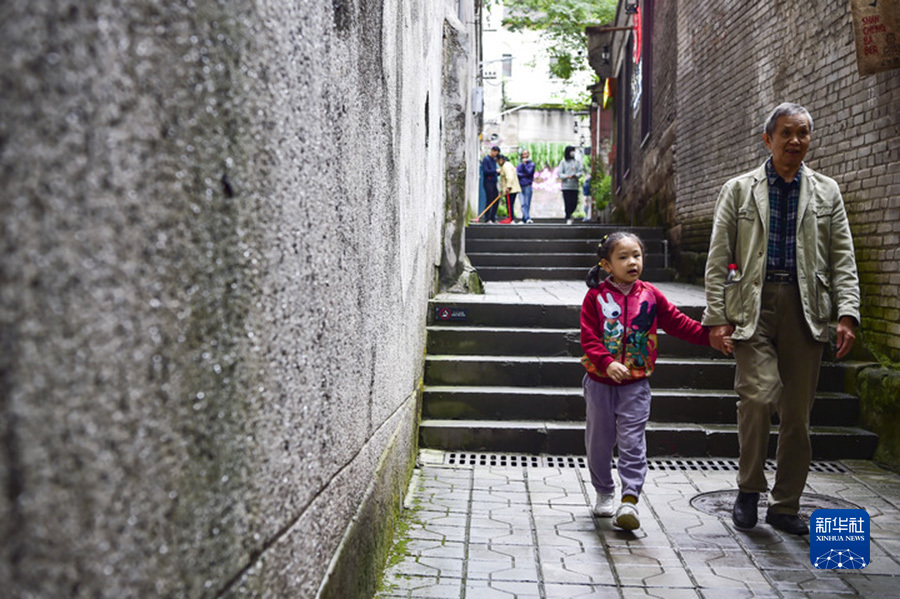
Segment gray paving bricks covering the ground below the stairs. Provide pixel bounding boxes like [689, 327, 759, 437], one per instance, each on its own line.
[376, 450, 900, 599]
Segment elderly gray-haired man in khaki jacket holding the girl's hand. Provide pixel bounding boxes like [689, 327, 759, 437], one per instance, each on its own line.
[703, 103, 859, 535]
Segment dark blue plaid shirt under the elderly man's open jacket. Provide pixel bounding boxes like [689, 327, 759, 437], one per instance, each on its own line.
[766, 158, 802, 271]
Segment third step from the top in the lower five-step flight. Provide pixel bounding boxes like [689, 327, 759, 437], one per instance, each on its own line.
[425, 355, 860, 392]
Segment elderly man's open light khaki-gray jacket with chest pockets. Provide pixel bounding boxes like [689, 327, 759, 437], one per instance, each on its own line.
[703, 164, 860, 342]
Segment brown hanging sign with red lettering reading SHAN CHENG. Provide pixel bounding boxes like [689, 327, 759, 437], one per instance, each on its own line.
[850, 0, 900, 76]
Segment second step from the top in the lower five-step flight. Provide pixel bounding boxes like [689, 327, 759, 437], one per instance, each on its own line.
[427, 325, 725, 359]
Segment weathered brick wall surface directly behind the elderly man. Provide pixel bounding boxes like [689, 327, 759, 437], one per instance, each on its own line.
[676, 0, 900, 362]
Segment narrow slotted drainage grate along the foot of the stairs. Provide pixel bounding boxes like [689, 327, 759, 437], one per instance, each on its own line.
[443, 452, 847, 474]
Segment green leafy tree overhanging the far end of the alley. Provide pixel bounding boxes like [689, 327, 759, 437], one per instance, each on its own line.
[503, 0, 618, 80]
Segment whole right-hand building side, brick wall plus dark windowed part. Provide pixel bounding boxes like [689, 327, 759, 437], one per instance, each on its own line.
[591, 0, 900, 362]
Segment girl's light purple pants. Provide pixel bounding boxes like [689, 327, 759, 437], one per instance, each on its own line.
[582, 375, 650, 497]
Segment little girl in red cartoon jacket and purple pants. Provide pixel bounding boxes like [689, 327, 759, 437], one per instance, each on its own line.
[581, 231, 730, 530]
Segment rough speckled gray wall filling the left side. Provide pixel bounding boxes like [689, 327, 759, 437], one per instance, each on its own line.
[0, 0, 464, 597]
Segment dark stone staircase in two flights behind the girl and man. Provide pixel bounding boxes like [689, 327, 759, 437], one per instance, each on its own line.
[420, 220, 877, 459]
